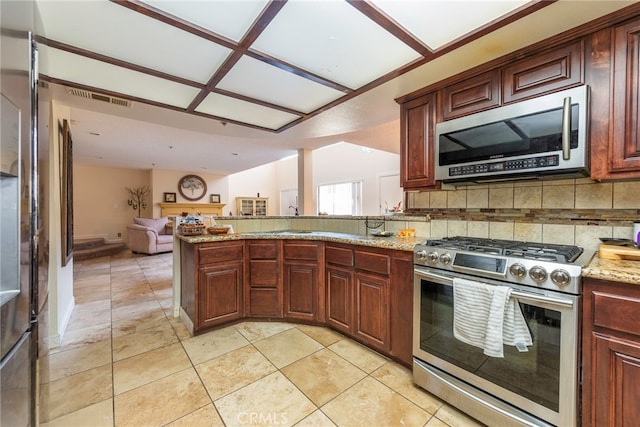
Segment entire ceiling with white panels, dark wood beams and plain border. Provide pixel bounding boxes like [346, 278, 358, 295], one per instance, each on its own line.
[37, 0, 637, 174]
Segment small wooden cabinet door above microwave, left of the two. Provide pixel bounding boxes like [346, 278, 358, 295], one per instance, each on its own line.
[442, 70, 501, 120]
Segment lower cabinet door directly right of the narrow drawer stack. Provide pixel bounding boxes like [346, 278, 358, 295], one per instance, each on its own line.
[284, 261, 319, 321]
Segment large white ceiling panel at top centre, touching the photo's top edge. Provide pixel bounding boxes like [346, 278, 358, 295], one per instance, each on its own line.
[252, 1, 420, 89]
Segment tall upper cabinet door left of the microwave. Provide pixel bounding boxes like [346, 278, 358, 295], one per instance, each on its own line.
[400, 93, 438, 190]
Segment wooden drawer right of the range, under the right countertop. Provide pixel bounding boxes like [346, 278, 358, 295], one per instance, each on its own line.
[592, 292, 640, 335]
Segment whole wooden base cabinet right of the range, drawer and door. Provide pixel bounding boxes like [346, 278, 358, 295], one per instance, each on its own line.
[582, 280, 640, 427]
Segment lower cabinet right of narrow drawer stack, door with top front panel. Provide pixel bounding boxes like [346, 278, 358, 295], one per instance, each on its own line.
[283, 240, 324, 322]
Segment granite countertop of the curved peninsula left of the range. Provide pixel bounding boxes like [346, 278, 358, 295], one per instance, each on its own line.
[176, 231, 425, 251]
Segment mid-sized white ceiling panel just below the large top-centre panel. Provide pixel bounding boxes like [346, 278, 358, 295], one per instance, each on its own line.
[217, 56, 344, 113]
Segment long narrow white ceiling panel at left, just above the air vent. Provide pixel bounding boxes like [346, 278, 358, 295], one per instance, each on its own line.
[40, 46, 198, 108]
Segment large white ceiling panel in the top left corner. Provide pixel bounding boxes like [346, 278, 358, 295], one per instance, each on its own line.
[35, 1, 231, 84]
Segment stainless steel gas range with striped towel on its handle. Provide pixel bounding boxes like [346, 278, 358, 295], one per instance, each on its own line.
[413, 237, 593, 427]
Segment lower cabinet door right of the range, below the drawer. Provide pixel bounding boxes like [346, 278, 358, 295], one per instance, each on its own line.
[583, 333, 640, 426]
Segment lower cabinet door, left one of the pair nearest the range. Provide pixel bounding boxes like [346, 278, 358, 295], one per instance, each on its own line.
[326, 266, 353, 333]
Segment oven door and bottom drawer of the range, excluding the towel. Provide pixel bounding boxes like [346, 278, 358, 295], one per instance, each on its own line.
[413, 266, 580, 426]
